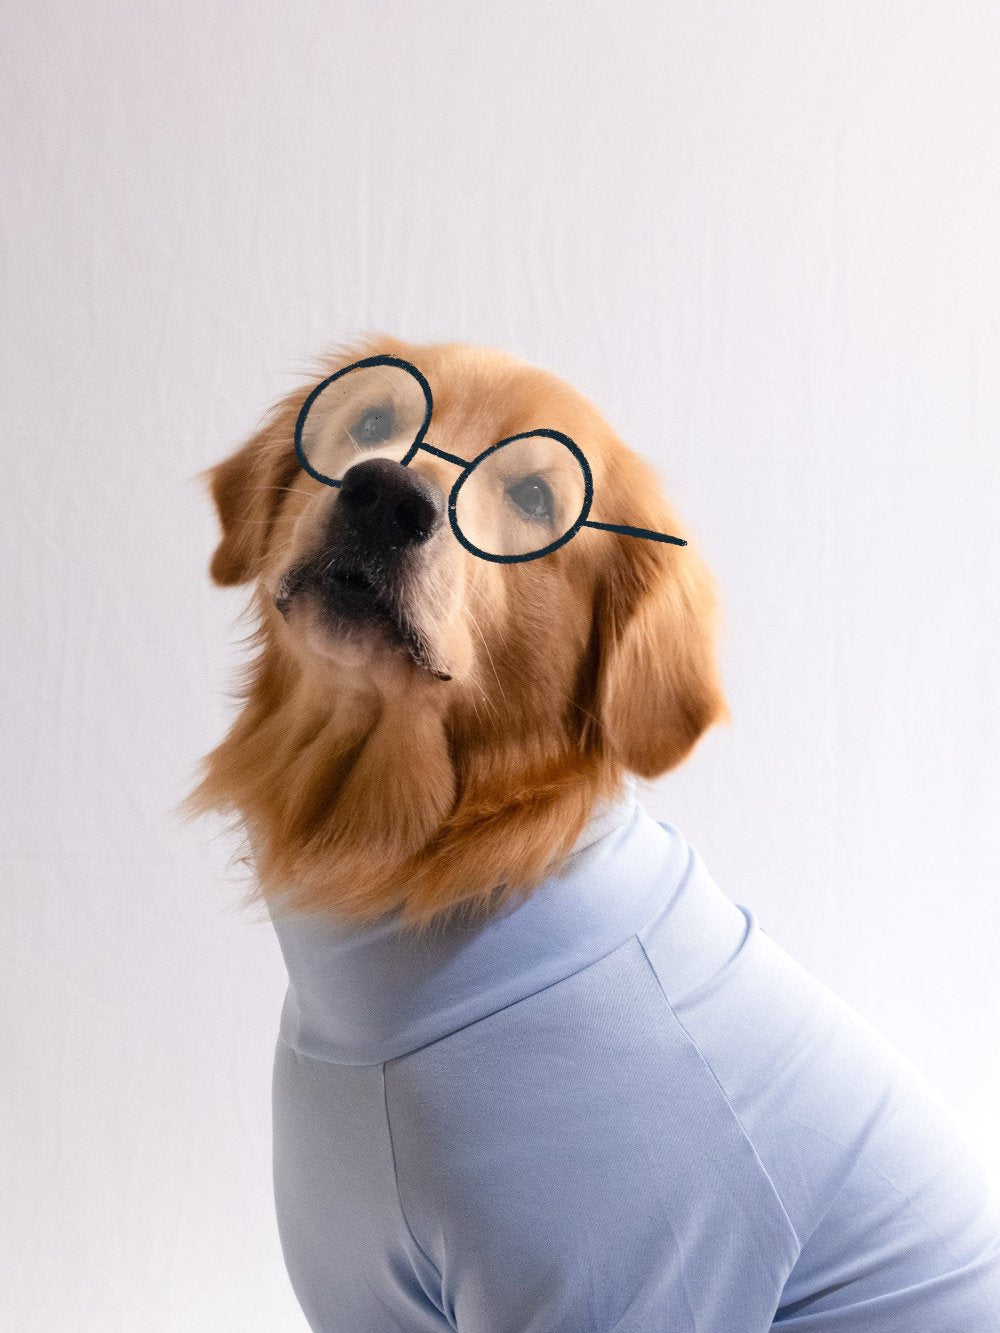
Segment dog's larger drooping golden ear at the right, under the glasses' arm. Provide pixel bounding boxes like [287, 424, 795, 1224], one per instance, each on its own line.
[593, 477, 731, 778]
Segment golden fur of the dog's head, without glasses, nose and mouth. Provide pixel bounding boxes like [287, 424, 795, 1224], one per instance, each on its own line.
[179, 336, 729, 933]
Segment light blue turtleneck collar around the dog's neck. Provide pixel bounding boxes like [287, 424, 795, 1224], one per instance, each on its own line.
[272, 777, 689, 1065]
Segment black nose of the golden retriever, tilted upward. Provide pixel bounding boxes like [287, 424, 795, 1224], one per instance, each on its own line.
[339, 459, 444, 547]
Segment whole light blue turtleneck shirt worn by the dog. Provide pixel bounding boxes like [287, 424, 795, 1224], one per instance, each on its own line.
[266, 782, 1000, 1333]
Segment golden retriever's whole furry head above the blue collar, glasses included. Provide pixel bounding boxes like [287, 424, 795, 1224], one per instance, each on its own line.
[184, 337, 728, 930]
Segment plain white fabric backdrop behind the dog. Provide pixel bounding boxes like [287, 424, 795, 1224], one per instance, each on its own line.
[0, 0, 1000, 1333]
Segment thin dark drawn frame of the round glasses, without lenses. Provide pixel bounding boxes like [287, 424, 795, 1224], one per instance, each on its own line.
[295, 355, 687, 565]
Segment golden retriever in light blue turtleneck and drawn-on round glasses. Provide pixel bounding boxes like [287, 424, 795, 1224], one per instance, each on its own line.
[183, 335, 1000, 1333]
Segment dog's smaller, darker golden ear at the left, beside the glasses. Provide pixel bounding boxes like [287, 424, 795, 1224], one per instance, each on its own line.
[197, 393, 303, 588]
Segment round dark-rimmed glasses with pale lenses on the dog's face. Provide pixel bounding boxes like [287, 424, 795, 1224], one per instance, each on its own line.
[295, 356, 687, 564]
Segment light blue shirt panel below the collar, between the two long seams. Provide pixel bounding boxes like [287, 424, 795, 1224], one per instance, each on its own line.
[384, 937, 800, 1333]
